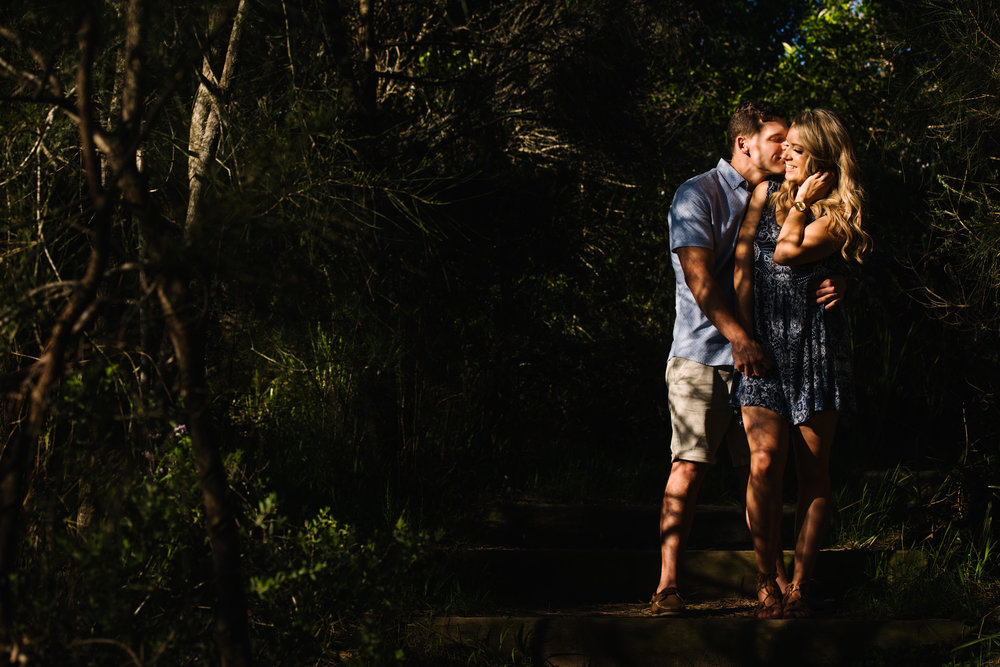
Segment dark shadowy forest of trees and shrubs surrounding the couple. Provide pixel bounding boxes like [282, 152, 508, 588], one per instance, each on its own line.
[0, 0, 1000, 664]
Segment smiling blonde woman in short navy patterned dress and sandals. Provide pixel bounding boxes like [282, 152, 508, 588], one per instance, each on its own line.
[733, 109, 870, 618]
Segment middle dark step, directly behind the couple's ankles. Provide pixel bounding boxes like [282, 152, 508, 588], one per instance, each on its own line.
[450, 546, 880, 609]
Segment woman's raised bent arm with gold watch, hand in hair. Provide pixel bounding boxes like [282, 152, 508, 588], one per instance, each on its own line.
[774, 172, 842, 266]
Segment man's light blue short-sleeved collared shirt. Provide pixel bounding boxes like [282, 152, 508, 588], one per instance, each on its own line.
[667, 160, 750, 366]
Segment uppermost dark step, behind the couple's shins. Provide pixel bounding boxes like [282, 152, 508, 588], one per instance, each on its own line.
[476, 502, 795, 550]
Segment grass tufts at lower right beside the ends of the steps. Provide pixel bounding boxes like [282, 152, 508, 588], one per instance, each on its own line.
[832, 467, 1000, 665]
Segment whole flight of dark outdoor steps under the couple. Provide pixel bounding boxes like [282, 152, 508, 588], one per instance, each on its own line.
[425, 502, 969, 667]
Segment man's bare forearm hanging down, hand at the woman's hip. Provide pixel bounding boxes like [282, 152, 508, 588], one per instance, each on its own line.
[677, 246, 772, 375]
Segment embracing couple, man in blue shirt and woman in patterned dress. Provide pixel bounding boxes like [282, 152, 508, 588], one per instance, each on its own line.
[651, 101, 869, 618]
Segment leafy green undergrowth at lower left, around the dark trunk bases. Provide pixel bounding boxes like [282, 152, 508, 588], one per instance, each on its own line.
[14, 360, 466, 667]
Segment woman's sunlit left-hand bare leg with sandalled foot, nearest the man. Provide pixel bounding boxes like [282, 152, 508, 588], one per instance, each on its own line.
[743, 407, 788, 618]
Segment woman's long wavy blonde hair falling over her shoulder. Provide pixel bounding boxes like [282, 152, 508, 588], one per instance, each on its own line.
[772, 109, 871, 262]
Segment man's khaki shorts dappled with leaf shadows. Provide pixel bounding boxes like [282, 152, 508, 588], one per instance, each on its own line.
[666, 357, 750, 466]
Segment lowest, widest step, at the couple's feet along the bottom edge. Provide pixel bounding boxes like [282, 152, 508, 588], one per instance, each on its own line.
[420, 607, 970, 667]
